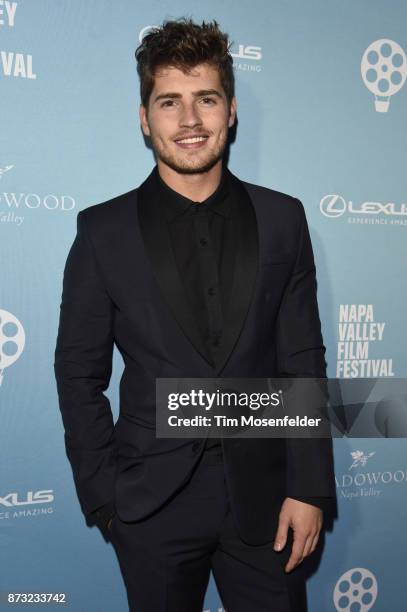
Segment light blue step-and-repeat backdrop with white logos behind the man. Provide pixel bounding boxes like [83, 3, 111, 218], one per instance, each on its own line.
[0, 0, 407, 612]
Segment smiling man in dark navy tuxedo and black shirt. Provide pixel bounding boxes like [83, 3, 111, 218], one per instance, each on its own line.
[55, 19, 335, 612]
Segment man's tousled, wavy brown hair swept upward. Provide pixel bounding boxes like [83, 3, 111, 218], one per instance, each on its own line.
[135, 17, 235, 108]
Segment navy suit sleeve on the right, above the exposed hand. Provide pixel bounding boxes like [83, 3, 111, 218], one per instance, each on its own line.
[277, 200, 336, 499]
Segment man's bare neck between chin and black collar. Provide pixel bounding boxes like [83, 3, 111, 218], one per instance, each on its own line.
[157, 159, 222, 202]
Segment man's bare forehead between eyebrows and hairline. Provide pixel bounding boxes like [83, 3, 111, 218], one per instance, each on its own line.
[154, 63, 221, 92]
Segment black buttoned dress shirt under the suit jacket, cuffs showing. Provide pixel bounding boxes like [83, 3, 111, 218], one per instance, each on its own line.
[92, 166, 329, 529]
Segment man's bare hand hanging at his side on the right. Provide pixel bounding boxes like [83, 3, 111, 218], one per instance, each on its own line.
[274, 497, 323, 572]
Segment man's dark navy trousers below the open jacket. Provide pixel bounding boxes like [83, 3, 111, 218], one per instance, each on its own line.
[110, 447, 307, 612]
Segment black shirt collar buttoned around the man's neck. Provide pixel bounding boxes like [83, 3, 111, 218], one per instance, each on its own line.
[154, 165, 230, 222]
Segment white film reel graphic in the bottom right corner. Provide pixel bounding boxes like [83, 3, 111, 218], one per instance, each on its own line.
[333, 567, 377, 612]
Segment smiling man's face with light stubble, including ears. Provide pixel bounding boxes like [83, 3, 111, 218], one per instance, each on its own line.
[140, 63, 236, 174]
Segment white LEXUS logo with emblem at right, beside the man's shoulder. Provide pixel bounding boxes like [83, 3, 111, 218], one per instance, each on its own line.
[319, 193, 407, 218]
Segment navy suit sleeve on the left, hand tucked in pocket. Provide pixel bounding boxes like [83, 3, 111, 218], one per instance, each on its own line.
[54, 211, 116, 515]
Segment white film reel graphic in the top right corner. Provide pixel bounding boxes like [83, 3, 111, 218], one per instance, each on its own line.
[360, 38, 407, 113]
